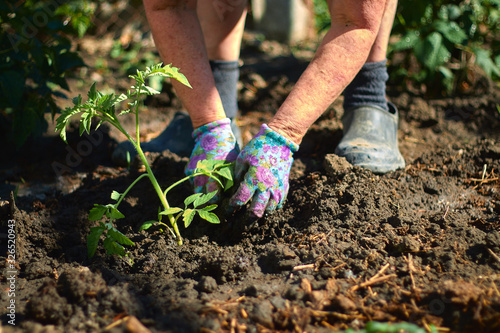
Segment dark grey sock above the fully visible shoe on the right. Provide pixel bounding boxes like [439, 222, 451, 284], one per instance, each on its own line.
[344, 60, 389, 111]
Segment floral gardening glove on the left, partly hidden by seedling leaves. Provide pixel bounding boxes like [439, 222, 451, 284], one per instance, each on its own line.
[184, 118, 239, 203]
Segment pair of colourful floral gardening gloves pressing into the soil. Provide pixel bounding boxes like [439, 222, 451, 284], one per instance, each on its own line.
[185, 118, 299, 217]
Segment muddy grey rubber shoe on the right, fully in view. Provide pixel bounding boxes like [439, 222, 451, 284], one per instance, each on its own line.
[335, 103, 405, 173]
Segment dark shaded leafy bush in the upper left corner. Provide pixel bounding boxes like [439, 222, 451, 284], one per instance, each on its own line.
[0, 0, 92, 148]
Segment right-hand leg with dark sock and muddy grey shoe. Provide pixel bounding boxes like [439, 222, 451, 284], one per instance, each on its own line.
[335, 0, 405, 173]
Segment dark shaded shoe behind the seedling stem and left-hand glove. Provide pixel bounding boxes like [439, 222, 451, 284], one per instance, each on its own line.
[111, 112, 241, 166]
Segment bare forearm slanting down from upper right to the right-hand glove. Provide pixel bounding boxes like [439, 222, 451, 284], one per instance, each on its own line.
[269, 1, 384, 144]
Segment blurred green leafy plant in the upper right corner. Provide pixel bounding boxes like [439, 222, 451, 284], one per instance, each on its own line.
[389, 0, 500, 95]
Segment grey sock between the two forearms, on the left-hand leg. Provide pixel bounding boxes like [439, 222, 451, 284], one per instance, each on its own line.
[210, 60, 240, 118]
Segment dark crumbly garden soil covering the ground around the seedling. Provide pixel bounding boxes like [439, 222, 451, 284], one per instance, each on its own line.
[0, 32, 500, 332]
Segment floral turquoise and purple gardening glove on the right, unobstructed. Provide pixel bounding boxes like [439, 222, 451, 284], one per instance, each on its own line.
[229, 124, 299, 217]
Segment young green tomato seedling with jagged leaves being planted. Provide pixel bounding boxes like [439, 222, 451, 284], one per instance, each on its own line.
[56, 63, 233, 257]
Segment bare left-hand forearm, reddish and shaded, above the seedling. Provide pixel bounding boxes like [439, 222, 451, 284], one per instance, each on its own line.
[144, 0, 225, 128]
